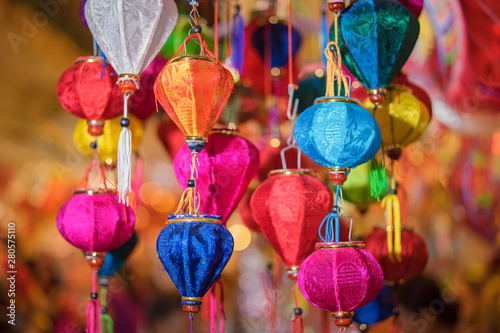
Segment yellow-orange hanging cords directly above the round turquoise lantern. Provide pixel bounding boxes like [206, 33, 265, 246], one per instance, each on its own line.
[324, 13, 350, 97]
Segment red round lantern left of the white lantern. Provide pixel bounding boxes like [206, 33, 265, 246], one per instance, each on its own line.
[57, 57, 123, 136]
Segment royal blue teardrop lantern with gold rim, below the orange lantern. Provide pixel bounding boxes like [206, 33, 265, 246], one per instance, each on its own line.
[156, 215, 234, 314]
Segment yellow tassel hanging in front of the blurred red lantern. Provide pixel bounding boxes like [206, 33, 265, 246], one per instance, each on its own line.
[382, 178, 402, 262]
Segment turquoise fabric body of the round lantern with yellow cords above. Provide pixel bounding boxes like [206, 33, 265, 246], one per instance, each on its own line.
[294, 98, 381, 168]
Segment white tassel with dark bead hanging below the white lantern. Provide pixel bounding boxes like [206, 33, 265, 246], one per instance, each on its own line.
[116, 93, 132, 206]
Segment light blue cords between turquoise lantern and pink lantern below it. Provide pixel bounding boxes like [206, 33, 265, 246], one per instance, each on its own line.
[318, 185, 352, 243]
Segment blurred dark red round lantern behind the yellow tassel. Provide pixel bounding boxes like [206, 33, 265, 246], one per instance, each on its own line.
[365, 229, 428, 282]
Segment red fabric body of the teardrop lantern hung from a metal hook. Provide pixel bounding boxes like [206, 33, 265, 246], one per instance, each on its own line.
[250, 174, 332, 267]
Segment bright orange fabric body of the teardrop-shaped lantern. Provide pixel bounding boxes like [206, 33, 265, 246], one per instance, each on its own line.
[154, 57, 234, 137]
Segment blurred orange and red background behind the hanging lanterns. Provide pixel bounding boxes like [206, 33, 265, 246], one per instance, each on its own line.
[0, 0, 500, 333]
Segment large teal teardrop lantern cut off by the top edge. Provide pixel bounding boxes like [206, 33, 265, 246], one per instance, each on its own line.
[330, 0, 420, 104]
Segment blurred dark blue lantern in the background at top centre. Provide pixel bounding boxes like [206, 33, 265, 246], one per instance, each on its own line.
[252, 22, 302, 67]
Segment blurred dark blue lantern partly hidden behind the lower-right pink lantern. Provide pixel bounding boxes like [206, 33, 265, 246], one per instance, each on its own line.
[353, 285, 395, 326]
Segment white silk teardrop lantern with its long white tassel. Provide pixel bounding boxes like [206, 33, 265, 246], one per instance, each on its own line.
[85, 0, 178, 204]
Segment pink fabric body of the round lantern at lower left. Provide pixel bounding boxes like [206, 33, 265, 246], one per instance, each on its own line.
[57, 192, 135, 252]
